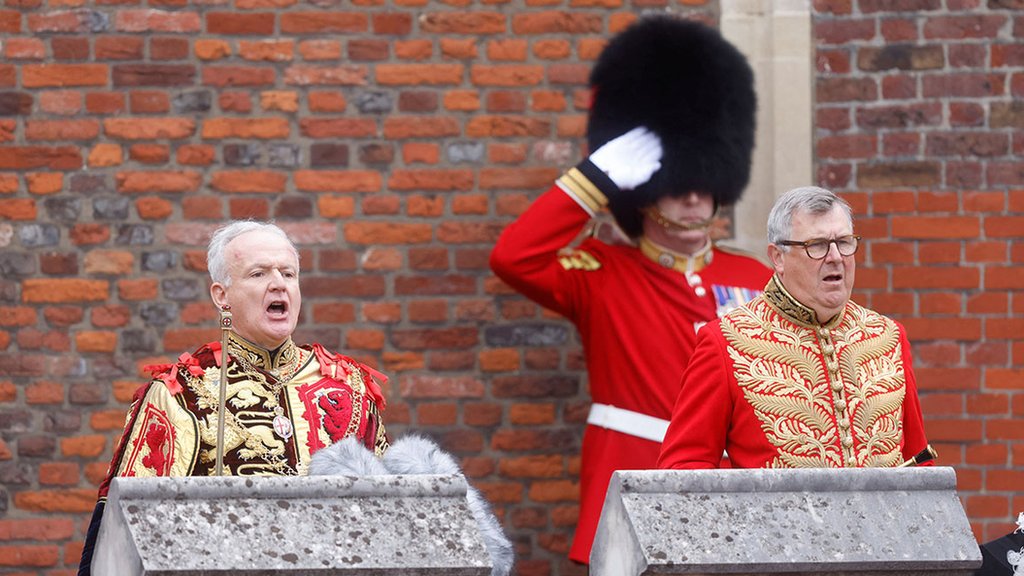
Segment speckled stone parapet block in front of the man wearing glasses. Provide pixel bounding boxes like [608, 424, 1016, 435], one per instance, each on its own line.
[590, 466, 981, 576]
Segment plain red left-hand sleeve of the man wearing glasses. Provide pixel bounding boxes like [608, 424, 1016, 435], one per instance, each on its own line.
[657, 322, 733, 468]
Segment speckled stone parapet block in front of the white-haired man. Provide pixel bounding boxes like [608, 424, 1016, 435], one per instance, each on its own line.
[92, 475, 492, 576]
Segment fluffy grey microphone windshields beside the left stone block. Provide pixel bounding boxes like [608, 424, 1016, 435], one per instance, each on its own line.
[309, 435, 515, 576]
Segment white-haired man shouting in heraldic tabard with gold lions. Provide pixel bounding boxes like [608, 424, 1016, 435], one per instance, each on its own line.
[79, 220, 388, 574]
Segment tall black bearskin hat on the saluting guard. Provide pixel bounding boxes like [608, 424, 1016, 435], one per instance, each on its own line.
[587, 14, 757, 238]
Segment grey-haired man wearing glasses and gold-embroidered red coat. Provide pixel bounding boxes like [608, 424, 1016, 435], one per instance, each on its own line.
[658, 187, 928, 468]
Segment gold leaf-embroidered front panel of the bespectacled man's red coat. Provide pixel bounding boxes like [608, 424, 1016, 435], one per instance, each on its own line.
[722, 278, 906, 467]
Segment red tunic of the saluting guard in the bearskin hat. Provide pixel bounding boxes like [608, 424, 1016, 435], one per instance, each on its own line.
[490, 182, 771, 563]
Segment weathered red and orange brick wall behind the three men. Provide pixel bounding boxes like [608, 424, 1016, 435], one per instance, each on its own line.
[0, 0, 1024, 575]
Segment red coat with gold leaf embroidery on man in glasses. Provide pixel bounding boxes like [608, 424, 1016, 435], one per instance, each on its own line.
[658, 278, 928, 468]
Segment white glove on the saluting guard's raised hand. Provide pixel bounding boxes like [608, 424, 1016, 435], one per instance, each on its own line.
[588, 126, 662, 190]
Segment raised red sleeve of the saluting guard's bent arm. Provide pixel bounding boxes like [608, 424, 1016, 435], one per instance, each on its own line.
[490, 186, 591, 316]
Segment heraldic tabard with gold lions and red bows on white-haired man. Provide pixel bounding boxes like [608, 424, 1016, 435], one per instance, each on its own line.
[80, 333, 388, 574]
